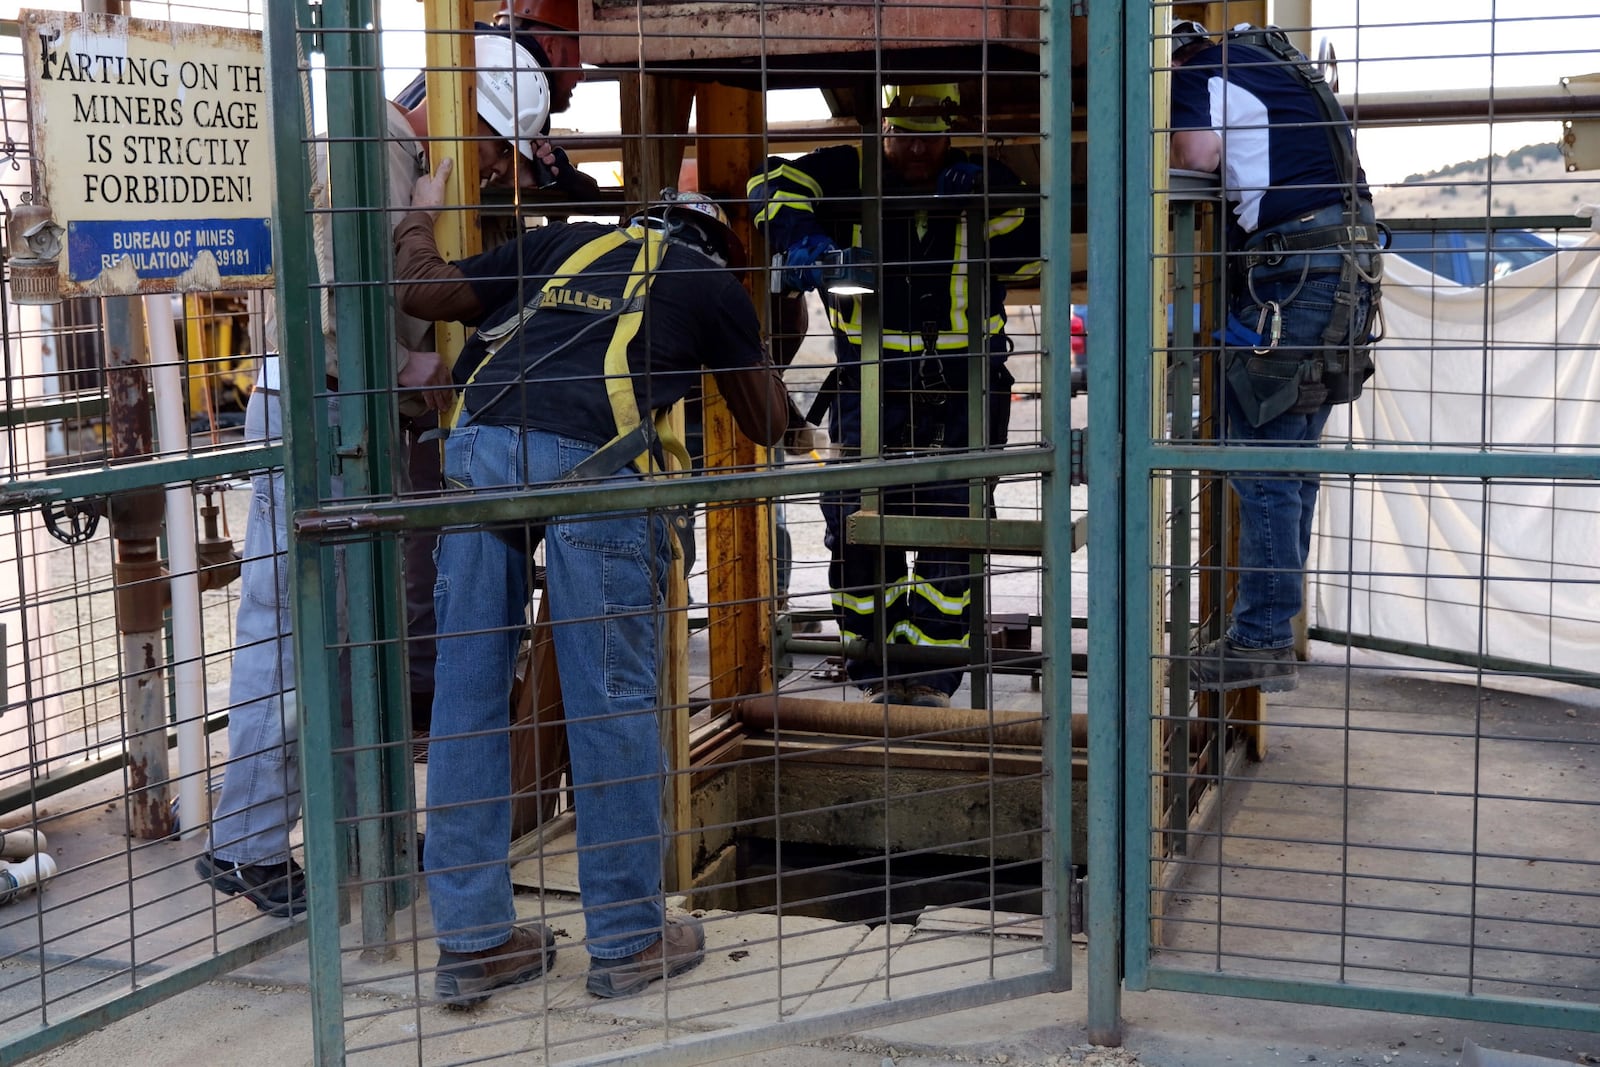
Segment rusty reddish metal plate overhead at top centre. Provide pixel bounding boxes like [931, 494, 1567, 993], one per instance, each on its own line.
[578, 0, 1040, 69]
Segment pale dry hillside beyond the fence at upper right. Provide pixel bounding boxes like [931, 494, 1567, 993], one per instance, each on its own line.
[1373, 144, 1600, 219]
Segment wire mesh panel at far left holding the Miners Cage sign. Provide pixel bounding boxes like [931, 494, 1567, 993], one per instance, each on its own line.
[0, 3, 331, 1062]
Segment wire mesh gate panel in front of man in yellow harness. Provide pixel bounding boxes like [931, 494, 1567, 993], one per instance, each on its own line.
[269, 3, 1083, 1062]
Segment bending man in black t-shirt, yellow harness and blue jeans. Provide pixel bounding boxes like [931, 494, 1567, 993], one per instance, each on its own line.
[395, 168, 790, 1006]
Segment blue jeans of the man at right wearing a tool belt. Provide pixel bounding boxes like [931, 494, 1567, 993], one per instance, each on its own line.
[1227, 275, 1365, 648]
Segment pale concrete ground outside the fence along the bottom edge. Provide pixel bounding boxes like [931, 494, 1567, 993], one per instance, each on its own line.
[18, 950, 1600, 1067]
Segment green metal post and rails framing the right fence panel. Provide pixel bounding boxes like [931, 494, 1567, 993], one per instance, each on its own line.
[1107, 0, 1600, 1041]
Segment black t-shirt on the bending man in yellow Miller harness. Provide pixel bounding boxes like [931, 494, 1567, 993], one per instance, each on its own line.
[456, 222, 771, 445]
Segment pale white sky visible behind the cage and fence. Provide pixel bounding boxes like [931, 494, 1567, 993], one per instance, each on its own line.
[0, 0, 1600, 182]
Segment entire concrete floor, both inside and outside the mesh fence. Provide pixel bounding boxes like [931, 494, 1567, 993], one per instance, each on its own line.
[0, 383, 1600, 1067]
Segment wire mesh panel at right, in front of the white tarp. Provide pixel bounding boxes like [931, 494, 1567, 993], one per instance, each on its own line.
[1128, 5, 1600, 1027]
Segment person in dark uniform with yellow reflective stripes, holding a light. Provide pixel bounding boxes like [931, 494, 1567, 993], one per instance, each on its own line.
[749, 85, 1040, 707]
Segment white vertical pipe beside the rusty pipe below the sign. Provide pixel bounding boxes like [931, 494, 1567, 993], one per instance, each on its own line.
[144, 293, 211, 837]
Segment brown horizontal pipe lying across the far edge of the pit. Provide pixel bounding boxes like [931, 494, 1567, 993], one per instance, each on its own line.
[733, 693, 1090, 749]
